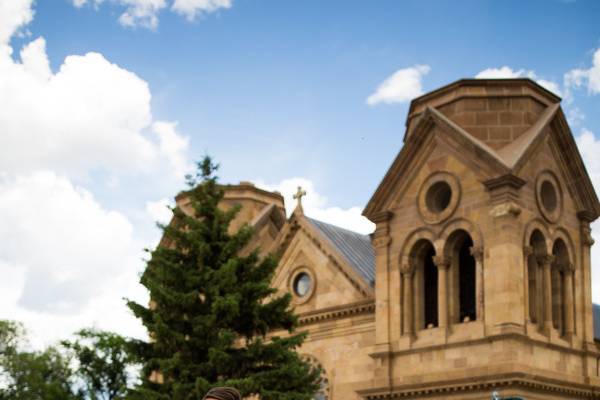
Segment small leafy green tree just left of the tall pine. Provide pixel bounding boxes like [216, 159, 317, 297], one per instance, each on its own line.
[62, 329, 136, 400]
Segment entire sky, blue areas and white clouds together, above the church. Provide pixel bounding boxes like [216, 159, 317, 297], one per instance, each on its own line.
[0, 0, 600, 345]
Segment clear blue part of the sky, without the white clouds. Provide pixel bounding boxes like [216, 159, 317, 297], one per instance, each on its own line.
[25, 0, 600, 207]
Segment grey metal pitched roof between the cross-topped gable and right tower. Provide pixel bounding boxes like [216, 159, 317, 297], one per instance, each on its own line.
[306, 217, 375, 286]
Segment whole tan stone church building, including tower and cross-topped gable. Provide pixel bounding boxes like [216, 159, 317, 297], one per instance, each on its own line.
[179, 79, 600, 400]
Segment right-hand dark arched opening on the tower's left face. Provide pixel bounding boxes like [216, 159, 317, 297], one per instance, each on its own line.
[446, 230, 477, 323]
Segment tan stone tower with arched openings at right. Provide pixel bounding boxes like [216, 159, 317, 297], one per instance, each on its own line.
[359, 79, 600, 399]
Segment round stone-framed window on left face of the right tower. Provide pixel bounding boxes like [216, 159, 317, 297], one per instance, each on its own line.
[417, 172, 460, 224]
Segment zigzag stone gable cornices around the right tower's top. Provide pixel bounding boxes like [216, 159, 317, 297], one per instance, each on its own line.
[363, 104, 600, 220]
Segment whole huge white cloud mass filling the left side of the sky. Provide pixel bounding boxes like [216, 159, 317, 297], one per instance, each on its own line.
[0, 0, 189, 345]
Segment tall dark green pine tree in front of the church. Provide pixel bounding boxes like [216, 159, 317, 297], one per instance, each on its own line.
[128, 157, 320, 400]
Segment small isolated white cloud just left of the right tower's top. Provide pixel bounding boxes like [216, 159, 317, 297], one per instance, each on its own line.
[367, 65, 431, 106]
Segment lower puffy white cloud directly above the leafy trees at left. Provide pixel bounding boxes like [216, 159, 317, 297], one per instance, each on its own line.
[0, 171, 144, 341]
